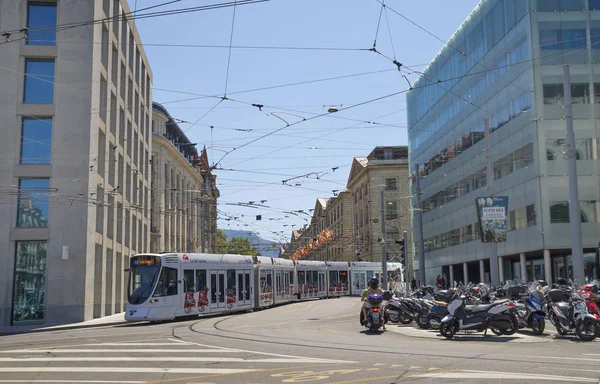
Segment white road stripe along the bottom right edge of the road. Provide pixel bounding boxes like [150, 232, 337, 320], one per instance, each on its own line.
[408, 370, 598, 383]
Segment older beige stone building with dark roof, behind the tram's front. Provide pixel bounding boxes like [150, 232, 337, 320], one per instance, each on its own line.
[150, 103, 219, 253]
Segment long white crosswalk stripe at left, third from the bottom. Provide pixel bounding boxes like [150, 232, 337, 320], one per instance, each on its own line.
[0, 356, 350, 364]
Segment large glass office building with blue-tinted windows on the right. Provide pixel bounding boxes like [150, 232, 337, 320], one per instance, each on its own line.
[407, 0, 600, 283]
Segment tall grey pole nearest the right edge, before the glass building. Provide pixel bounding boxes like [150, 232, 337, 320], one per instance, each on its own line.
[563, 64, 585, 284]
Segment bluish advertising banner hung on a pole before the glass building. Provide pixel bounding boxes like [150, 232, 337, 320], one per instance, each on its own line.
[475, 196, 508, 243]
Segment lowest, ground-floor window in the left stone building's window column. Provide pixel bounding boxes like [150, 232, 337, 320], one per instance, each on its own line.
[12, 241, 47, 325]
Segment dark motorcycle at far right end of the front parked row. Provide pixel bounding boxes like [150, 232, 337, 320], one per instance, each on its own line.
[545, 287, 600, 341]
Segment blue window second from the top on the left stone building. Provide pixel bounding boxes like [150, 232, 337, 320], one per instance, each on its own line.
[23, 59, 54, 104]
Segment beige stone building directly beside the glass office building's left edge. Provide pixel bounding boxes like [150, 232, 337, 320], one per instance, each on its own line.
[347, 146, 412, 278]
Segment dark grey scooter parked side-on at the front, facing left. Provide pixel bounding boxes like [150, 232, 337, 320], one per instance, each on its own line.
[440, 286, 519, 339]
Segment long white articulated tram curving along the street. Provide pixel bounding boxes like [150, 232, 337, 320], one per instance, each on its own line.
[125, 253, 401, 321]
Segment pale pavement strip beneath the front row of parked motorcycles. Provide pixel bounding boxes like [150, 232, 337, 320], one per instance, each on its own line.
[386, 324, 554, 343]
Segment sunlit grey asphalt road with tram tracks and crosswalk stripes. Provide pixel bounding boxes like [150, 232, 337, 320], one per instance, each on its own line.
[0, 298, 600, 384]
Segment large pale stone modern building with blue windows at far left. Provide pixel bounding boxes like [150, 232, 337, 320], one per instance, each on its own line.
[0, 0, 152, 326]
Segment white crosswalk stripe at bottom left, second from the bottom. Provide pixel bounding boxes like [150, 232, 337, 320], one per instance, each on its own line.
[0, 367, 256, 374]
